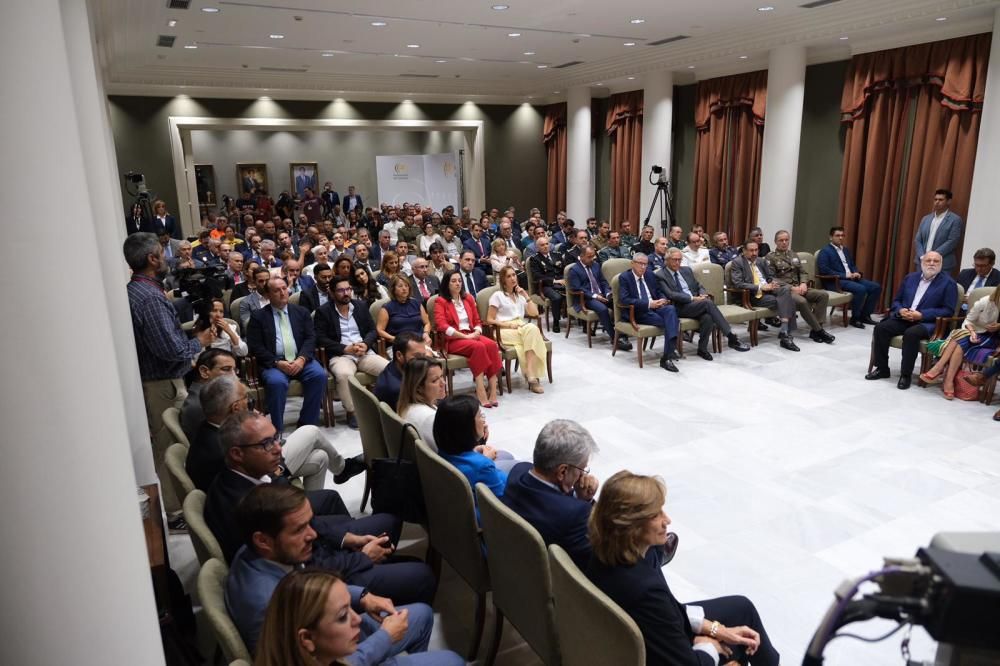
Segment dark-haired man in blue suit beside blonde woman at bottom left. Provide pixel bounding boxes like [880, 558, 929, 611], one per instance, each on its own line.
[225, 484, 456, 665]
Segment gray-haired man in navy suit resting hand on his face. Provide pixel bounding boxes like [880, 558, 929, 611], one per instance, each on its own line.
[502, 419, 677, 568]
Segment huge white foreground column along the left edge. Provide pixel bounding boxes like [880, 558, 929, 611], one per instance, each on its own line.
[0, 0, 164, 666]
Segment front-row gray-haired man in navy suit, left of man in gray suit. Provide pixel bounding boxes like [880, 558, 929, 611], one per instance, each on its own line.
[618, 252, 680, 372]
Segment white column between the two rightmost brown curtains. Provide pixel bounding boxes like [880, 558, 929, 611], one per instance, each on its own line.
[756, 46, 806, 247]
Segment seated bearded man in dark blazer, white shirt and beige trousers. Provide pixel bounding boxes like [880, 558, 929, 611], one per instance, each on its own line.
[315, 276, 390, 430]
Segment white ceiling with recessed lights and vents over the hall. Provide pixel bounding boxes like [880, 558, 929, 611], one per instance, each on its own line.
[90, 0, 1000, 103]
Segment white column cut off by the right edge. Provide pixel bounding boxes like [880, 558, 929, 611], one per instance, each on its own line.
[962, 9, 1000, 266]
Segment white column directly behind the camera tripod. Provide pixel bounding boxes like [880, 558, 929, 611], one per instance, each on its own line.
[632, 72, 672, 236]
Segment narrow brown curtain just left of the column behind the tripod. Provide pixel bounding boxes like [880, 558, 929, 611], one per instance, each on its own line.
[604, 90, 642, 229]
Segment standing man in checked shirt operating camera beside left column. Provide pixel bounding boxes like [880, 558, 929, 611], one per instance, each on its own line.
[122, 233, 215, 530]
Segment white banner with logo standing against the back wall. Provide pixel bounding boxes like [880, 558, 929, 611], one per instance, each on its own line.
[375, 153, 459, 211]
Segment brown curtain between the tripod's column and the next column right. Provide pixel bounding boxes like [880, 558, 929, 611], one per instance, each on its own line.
[693, 71, 767, 245]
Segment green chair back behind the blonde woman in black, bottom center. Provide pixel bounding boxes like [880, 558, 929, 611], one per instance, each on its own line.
[549, 544, 644, 666]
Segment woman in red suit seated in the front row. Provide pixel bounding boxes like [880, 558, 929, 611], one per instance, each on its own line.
[434, 271, 502, 407]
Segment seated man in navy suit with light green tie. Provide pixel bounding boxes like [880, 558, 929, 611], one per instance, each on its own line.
[247, 276, 326, 432]
